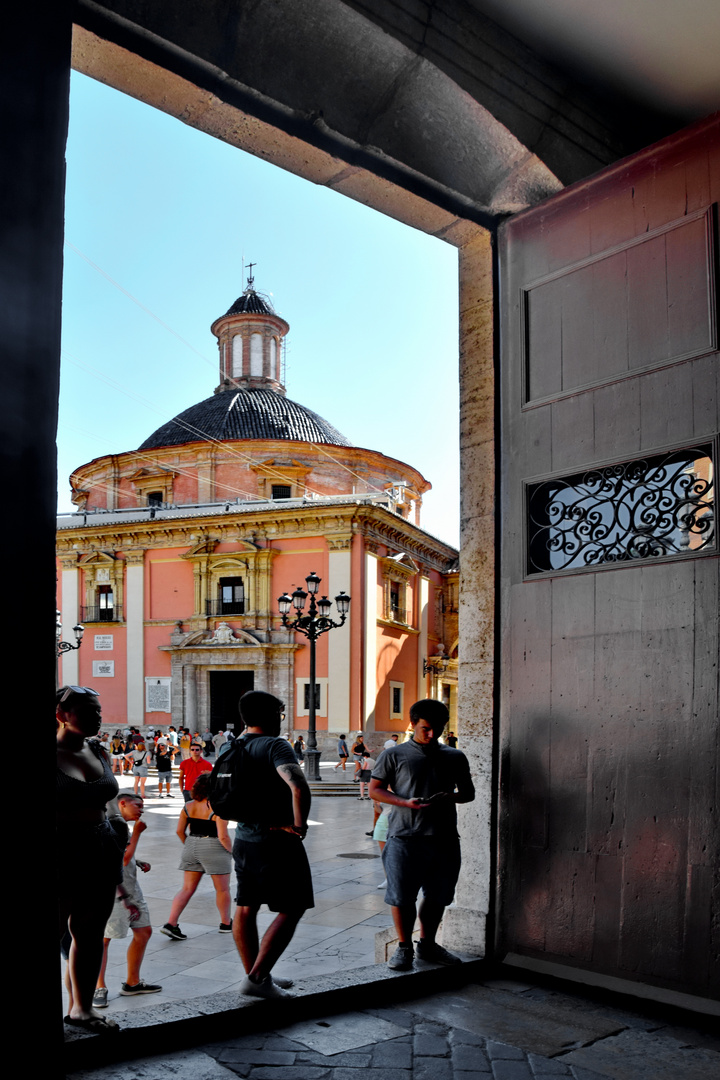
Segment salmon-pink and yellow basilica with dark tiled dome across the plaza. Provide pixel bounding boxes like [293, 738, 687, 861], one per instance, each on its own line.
[57, 276, 459, 751]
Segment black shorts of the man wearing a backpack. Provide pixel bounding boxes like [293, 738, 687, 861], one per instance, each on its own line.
[232, 829, 315, 913]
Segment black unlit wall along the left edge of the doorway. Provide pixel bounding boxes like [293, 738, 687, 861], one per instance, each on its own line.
[0, 0, 71, 1045]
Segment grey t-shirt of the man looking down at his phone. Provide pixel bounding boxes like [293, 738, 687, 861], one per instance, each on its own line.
[372, 739, 474, 839]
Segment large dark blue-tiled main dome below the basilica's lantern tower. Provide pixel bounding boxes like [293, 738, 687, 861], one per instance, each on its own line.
[138, 389, 352, 450]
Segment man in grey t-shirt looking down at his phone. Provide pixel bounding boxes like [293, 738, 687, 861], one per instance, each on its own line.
[370, 698, 475, 971]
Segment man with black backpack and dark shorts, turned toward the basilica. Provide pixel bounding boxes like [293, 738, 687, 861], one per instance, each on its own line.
[209, 690, 314, 998]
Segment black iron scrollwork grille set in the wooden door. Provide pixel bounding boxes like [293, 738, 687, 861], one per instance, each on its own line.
[528, 444, 717, 575]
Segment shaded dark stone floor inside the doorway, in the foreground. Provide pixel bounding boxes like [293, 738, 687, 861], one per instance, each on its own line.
[68, 964, 720, 1080]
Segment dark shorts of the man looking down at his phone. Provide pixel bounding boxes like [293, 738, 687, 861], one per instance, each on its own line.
[382, 836, 460, 907]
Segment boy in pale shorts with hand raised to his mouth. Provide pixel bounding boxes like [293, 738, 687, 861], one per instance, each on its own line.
[93, 792, 162, 1009]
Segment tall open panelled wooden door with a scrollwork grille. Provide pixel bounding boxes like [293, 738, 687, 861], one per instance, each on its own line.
[497, 117, 720, 996]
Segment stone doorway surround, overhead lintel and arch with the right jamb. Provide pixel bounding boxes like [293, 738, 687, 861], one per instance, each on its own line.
[64, 6, 511, 954]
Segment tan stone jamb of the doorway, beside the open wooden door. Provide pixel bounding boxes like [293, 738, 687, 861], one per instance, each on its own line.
[444, 229, 495, 956]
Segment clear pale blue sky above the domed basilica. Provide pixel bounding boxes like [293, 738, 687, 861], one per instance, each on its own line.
[58, 73, 459, 544]
